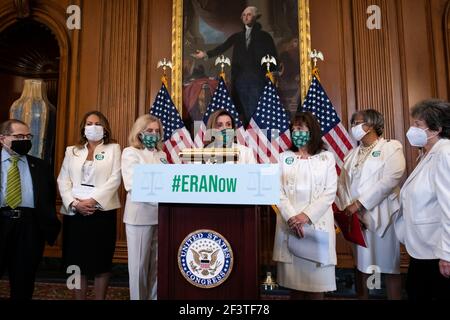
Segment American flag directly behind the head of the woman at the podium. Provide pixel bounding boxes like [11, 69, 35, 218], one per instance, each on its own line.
[194, 77, 245, 148]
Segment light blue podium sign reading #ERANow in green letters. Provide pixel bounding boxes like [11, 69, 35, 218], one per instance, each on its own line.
[131, 164, 280, 205]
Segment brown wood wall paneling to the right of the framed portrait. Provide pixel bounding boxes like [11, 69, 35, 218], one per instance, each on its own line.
[310, 0, 449, 266]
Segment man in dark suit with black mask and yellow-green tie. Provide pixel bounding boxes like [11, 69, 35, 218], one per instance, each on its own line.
[0, 120, 60, 299]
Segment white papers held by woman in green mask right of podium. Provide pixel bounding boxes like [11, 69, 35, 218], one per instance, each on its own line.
[288, 224, 331, 265]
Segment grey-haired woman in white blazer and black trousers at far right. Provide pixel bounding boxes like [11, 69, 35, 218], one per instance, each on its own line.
[395, 100, 450, 300]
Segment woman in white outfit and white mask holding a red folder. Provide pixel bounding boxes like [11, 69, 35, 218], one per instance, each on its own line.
[336, 109, 405, 300]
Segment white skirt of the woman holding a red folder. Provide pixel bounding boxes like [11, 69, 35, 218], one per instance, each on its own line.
[353, 224, 400, 274]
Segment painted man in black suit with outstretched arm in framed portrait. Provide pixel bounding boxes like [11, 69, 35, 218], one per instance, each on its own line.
[193, 7, 277, 124]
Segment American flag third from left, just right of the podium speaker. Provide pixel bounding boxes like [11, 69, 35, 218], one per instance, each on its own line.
[247, 80, 291, 163]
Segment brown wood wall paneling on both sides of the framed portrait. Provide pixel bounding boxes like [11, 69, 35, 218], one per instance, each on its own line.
[0, 0, 450, 266]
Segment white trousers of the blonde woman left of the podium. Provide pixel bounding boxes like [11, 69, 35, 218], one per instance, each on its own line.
[125, 224, 158, 300]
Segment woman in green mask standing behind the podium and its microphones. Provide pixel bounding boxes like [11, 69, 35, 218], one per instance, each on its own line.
[207, 109, 257, 164]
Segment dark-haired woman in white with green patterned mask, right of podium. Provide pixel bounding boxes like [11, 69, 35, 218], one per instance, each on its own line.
[273, 112, 337, 299]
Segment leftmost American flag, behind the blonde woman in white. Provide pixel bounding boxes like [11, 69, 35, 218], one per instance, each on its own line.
[150, 84, 193, 163]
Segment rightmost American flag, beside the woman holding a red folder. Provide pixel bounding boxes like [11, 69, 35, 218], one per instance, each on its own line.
[302, 76, 355, 174]
